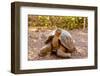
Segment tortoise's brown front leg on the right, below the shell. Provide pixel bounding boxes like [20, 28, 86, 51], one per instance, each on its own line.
[57, 46, 71, 58]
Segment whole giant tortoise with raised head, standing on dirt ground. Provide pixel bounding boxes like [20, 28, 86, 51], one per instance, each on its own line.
[39, 28, 76, 58]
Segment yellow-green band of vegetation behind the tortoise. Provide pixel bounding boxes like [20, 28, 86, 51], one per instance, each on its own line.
[28, 15, 88, 30]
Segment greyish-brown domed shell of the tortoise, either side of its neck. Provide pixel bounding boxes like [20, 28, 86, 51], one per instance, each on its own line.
[48, 29, 75, 51]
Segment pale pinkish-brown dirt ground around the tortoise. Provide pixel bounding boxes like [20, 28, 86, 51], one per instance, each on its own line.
[28, 29, 88, 60]
